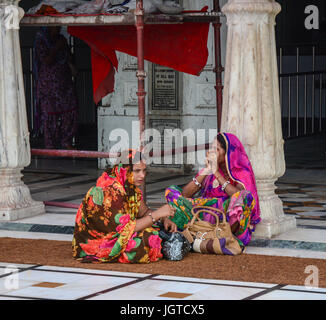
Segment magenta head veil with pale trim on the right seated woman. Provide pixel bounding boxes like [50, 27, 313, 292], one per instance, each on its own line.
[220, 132, 260, 224]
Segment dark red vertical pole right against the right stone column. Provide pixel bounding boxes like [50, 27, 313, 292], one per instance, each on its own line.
[213, 0, 224, 131]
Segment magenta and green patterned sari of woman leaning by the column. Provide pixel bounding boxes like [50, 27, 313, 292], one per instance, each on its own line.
[165, 133, 261, 246]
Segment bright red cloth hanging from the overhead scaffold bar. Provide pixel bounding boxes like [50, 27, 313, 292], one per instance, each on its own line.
[68, 7, 209, 103]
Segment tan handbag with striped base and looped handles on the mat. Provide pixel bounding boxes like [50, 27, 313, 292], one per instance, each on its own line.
[182, 206, 243, 255]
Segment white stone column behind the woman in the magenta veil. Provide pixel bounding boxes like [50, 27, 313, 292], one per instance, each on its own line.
[221, 0, 296, 238]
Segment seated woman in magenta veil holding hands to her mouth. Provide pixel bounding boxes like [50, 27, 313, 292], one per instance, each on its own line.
[165, 133, 261, 249]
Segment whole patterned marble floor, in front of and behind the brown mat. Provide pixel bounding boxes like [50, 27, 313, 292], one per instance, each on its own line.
[0, 132, 326, 300]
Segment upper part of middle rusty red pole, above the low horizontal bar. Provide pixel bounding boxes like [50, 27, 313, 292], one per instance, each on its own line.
[135, 0, 147, 149]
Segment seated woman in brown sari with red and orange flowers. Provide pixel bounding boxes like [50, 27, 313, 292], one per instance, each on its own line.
[72, 150, 177, 263]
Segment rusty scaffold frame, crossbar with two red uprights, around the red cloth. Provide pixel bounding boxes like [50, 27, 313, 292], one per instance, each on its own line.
[20, 0, 224, 147]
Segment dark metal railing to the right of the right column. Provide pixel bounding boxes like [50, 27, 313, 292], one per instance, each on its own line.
[278, 44, 326, 139]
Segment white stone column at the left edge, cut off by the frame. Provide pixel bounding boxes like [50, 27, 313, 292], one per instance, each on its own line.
[0, 0, 44, 220]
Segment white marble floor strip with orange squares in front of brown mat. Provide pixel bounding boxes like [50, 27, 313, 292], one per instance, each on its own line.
[0, 263, 326, 300]
